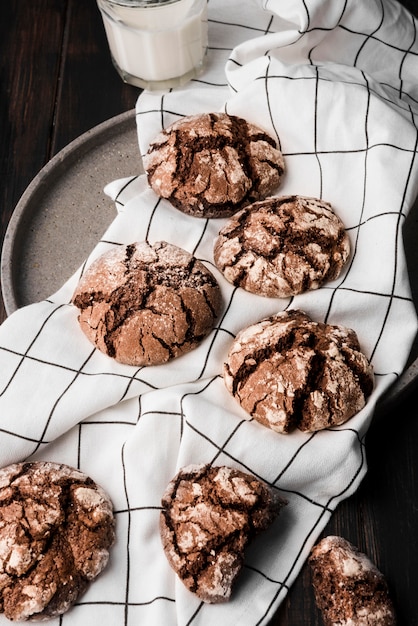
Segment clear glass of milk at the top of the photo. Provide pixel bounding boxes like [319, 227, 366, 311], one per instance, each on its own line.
[97, 0, 208, 90]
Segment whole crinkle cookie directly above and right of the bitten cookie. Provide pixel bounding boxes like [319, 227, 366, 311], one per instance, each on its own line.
[223, 310, 374, 433]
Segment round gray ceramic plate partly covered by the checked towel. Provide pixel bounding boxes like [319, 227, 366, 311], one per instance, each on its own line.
[1, 110, 418, 414]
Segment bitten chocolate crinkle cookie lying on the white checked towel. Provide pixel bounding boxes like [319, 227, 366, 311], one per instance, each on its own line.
[160, 465, 286, 603]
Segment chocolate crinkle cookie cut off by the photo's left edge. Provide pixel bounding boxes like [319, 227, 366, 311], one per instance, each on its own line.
[0, 462, 115, 621]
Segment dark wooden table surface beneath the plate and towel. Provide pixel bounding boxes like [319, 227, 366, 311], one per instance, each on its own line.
[0, 0, 418, 626]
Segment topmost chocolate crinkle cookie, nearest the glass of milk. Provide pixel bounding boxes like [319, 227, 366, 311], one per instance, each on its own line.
[143, 113, 284, 218]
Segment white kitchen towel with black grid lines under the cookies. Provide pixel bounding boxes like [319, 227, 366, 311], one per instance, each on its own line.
[0, 0, 418, 626]
